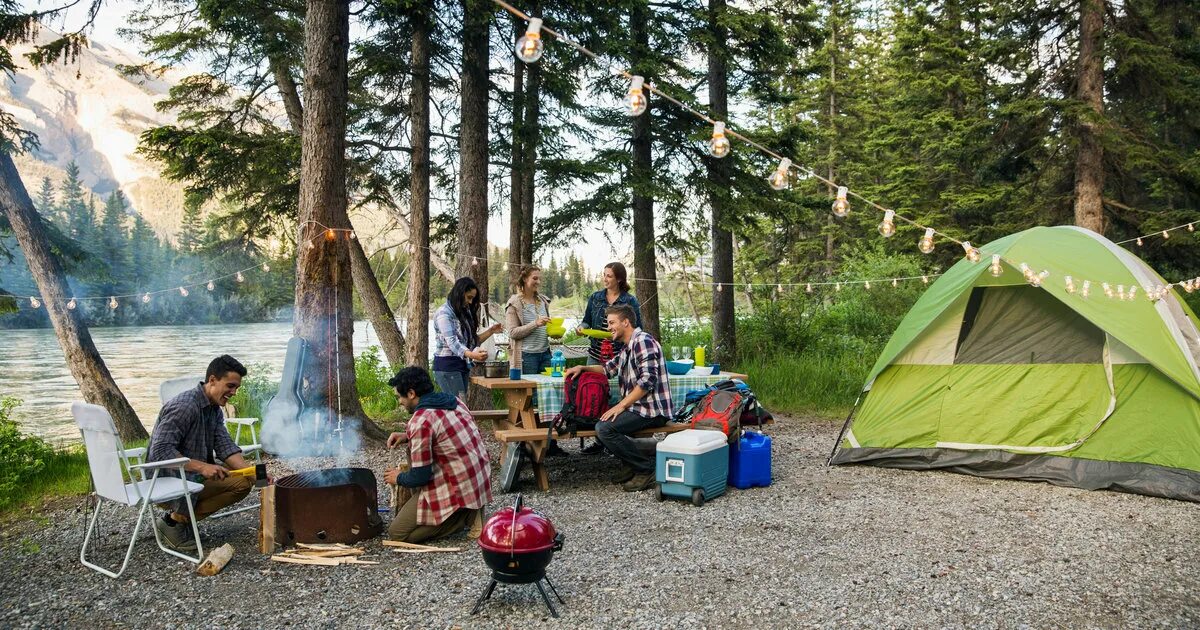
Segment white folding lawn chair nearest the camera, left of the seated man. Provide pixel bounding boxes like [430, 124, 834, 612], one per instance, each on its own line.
[71, 402, 204, 577]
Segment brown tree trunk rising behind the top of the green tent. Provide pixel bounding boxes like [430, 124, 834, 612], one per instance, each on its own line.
[1075, 0, 1104, 234]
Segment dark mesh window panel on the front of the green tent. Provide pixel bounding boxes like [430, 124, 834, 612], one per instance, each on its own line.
[954, 286, 1104, 365]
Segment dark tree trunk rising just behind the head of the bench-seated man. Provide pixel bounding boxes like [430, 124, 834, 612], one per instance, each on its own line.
[630, 6, 661, 338]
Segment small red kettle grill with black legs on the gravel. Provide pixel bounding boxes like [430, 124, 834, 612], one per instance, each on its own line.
[470, 494, 566, 618]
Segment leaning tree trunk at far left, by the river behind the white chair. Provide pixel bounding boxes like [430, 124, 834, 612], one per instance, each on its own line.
[0, 152, 149, 443]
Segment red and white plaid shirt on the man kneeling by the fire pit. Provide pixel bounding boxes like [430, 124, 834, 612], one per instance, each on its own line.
[407, 401, 492, 526]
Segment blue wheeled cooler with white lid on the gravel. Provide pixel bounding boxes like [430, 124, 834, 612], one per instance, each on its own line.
[654, 428, 730, 508]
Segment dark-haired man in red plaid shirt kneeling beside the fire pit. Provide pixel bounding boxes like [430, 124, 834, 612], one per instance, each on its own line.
[384, 366, 492, 542]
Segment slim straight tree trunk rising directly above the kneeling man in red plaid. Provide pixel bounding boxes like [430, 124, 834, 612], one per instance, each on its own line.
[407, 6, 431, 367]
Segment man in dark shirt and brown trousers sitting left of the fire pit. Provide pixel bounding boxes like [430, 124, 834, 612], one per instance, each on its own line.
[146, 354, 254, 551]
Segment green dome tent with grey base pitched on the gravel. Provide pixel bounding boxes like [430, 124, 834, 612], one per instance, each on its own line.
[830, 227, 1200, 502]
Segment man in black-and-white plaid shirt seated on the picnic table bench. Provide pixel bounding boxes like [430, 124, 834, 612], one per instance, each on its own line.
[566, 304, 674, 492]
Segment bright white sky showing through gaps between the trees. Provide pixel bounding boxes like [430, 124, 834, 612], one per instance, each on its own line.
[23, 0, 632, 274]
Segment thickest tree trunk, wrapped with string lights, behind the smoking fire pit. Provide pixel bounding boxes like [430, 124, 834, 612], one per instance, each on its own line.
[294, 0, 380, 437]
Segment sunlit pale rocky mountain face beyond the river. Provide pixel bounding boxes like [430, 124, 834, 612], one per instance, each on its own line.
[0, 26, 184, 238]
